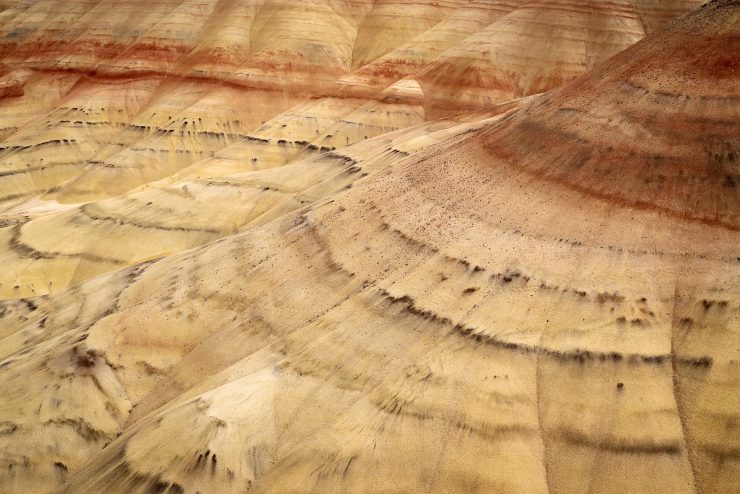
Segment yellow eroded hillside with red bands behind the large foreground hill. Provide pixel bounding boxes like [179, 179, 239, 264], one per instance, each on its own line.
[0, 0, 699, 299]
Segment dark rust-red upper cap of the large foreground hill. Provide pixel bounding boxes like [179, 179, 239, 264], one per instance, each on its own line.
[476, 0, 740, 230]
